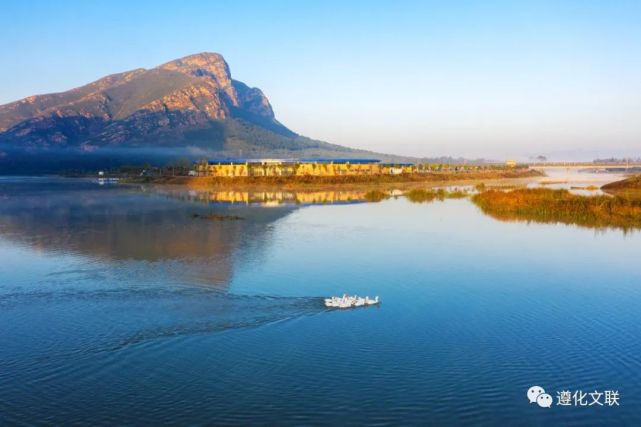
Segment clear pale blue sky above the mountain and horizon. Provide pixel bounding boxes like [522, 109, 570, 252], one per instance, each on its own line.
[0, 0, 641, 159]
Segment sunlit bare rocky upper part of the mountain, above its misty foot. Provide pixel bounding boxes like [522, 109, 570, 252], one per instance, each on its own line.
[0, 52, 296, 155]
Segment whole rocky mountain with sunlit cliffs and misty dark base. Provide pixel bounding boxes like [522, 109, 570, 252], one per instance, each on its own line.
[0, 53, 390, 172]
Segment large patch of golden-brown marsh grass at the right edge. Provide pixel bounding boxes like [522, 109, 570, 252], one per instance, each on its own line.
[472, 188, 641, 230]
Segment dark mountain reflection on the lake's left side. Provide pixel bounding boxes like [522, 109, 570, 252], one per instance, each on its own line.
[0, 180, 295, 284]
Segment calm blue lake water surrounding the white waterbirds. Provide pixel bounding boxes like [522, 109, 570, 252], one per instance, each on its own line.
[0, 177, 641, 425]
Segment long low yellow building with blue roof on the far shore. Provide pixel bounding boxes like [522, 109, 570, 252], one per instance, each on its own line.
[194, 159, 414, 177]
